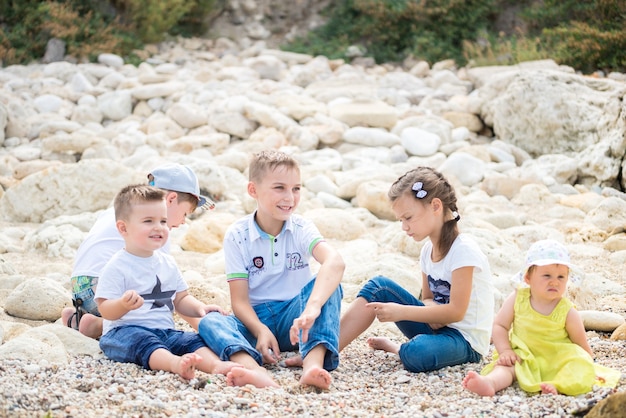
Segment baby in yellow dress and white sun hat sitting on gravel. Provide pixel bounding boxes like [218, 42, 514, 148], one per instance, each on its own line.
[463, 240, 621, 396]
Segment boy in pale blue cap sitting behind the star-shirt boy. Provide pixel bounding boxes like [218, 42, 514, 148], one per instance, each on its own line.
[61, 163, 215, 338]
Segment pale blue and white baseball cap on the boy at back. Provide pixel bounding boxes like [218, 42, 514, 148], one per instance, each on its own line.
[148, 163, 215, 209]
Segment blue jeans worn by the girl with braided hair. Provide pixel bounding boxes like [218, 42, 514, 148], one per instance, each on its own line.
[357, 276, 481, 372]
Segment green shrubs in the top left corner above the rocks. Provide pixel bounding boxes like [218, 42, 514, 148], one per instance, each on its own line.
[0, 0, 219, 65]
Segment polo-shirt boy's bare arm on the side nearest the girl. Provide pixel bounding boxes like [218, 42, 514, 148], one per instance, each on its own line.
[289, 241, 346, 344]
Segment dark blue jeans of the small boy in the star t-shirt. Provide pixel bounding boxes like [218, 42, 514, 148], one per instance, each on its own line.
[100, 325, 206, 370]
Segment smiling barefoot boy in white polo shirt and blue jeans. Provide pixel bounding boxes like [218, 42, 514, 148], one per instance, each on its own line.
[198, 150, 345, 389]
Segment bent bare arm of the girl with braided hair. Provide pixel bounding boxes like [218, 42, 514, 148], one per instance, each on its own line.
[367, 266, 474, 326]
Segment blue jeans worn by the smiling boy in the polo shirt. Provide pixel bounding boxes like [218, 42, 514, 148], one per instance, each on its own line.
[198, 280, 343, 371]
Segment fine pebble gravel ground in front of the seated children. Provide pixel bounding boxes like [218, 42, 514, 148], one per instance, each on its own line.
[0, 324, 626, 417]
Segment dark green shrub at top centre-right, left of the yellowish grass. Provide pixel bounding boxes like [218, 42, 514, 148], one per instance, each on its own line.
[283, 0, 495, 63]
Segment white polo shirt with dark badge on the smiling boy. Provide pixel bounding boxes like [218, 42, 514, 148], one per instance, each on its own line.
[224, 212, 324, 306]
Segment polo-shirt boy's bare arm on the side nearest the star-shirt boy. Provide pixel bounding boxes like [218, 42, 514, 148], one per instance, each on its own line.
[228, 280, 280, 364]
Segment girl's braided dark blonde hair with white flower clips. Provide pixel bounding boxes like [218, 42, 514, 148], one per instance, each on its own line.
[387, 167, 461, 258]
